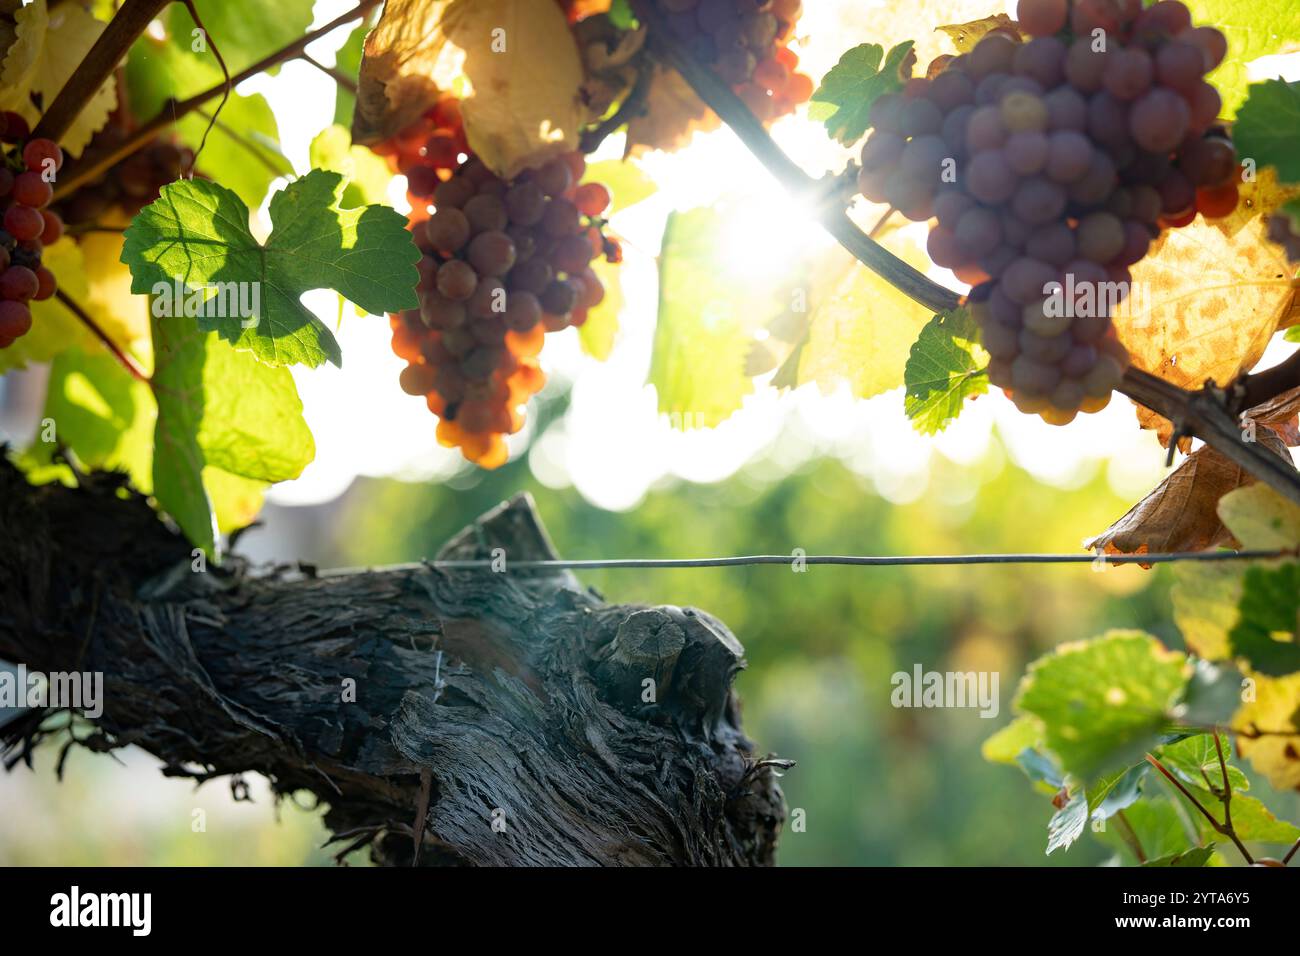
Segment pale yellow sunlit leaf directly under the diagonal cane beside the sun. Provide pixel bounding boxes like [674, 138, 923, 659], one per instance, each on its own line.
[798, 242, 933, 398]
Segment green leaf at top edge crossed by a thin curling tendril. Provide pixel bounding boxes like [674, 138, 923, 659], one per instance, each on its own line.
[166, 0, 312, 73]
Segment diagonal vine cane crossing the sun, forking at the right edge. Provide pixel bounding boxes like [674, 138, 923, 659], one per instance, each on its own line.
[638, 5, 1300, 503]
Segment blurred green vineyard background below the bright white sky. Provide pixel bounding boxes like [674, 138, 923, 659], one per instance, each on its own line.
[0, 418, 1206, 865]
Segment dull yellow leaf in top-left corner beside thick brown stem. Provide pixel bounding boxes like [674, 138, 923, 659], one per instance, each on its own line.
[0, 0, 117, 156]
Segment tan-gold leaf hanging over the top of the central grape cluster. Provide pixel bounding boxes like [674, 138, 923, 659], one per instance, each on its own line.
[352, 0, 588, 178]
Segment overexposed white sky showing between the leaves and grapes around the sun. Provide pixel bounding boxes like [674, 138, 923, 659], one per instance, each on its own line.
[241, 0, 1295, 510]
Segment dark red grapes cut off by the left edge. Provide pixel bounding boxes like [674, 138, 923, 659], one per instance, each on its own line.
[0, 112, 64, 349]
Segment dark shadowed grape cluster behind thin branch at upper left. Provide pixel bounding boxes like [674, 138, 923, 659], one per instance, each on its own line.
[57, 114, 194, 225]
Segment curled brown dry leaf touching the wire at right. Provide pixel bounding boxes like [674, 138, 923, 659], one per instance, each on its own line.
[1083, 429, 1291, 554]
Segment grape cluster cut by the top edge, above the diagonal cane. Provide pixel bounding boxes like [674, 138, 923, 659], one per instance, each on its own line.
[646, 0, 814, 122]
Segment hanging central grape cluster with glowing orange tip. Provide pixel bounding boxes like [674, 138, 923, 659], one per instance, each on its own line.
[377, 100, 621, 468]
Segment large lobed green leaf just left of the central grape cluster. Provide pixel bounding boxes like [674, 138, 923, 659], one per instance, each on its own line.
[122, 169, 420, 368]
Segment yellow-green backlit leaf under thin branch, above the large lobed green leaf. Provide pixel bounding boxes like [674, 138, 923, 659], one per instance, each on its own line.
[126, 39, 294, 209]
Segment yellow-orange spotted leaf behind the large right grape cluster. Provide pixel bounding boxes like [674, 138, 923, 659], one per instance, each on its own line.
[1114, 179, 1296, 445]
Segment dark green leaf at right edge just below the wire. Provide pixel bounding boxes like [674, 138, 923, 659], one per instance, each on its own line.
[1229, 561, 1300, 678]
